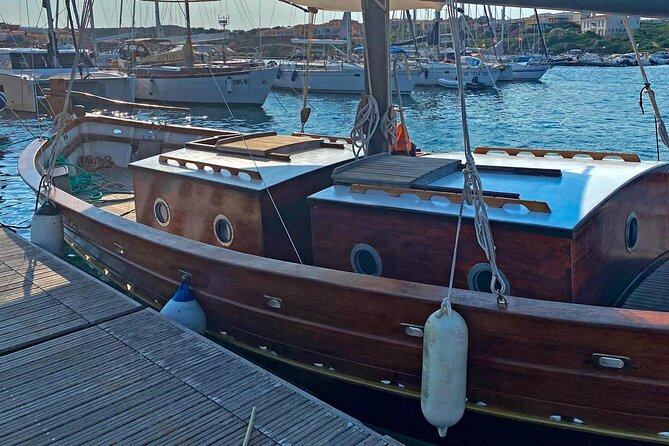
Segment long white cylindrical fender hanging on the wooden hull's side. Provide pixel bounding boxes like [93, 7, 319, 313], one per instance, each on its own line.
[420, 300, 469, 437]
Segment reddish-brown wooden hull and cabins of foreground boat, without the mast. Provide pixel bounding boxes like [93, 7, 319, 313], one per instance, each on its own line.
[20, 116, 669, 439]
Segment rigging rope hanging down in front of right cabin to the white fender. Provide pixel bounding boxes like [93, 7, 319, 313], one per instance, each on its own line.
[442, 0, 507, 308]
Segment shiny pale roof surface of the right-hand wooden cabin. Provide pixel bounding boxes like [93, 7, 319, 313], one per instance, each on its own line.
[309, 153, 667, 230]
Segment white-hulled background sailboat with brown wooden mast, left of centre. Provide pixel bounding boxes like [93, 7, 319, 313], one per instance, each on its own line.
[134, 0, 278, 106]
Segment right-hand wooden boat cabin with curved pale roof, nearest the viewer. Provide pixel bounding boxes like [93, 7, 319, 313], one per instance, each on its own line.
[309, 148, 669, 305]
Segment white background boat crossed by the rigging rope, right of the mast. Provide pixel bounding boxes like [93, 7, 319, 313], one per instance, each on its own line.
[416, 56, 501, 87]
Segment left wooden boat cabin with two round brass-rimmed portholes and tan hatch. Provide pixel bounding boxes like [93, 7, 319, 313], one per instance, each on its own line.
[130, 132, 353, 262]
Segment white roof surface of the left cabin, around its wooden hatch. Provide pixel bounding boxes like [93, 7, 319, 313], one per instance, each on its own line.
[130, 147, 353, 191]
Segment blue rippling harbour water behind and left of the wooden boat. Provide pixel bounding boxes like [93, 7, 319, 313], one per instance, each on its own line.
[0, 66, 669, 235]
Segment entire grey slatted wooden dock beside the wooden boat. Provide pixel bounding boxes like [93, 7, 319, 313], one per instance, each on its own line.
[0, 229, 399, 446]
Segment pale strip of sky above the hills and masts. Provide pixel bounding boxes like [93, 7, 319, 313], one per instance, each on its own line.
[0, 0, 560, 29]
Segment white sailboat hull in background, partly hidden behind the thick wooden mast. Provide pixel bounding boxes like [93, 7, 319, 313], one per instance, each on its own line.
[274, 62, 422, 94]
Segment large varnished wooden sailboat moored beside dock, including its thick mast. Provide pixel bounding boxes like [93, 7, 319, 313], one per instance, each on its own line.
[19, 0, 669, 444]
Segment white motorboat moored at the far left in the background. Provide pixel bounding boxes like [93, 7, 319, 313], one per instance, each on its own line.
[0, 47, 135, 113]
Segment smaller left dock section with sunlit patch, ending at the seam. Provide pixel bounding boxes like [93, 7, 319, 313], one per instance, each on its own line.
[0, 230, 141, 354]
